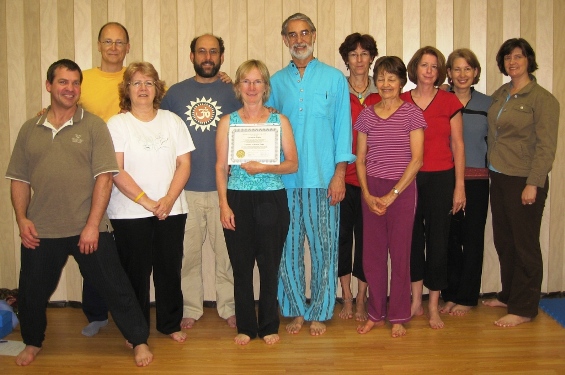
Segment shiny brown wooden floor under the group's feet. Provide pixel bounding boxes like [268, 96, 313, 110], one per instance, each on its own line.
[0, 304, 565, 375]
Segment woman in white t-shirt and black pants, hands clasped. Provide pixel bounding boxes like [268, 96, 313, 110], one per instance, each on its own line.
[108, 62, 194, 342]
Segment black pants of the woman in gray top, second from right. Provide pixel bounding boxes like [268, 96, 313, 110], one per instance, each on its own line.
[441, 179, 489, 306]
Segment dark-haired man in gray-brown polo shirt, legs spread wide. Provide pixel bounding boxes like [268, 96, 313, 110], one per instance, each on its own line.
[6, 59, 153, 366]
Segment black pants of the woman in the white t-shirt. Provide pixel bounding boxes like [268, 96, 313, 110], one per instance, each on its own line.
[111, 214, 186, 335]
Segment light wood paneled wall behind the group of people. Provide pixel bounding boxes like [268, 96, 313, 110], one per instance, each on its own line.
[0, 0, 565, 300]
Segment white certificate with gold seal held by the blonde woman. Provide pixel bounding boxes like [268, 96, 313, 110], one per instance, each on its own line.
[228, 123, 281, 165]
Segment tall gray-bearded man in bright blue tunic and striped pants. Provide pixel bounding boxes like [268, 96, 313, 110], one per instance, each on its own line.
[267, 13, 355, 336]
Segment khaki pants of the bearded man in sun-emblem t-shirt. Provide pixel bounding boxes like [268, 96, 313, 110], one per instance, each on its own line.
[181, 191, 235, 320]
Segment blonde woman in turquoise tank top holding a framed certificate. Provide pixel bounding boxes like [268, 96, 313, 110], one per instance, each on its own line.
[216, 60, 298, 345]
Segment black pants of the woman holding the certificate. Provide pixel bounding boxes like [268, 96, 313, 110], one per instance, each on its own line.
[224, 190, 290, 338]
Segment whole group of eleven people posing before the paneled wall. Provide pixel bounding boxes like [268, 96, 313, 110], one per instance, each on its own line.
[6, 13, 559, 366]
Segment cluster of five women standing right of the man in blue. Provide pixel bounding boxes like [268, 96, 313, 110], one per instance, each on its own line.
[339, 33, 559, 337]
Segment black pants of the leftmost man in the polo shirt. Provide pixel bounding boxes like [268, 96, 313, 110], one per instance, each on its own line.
[18, 233, 149, 347]
